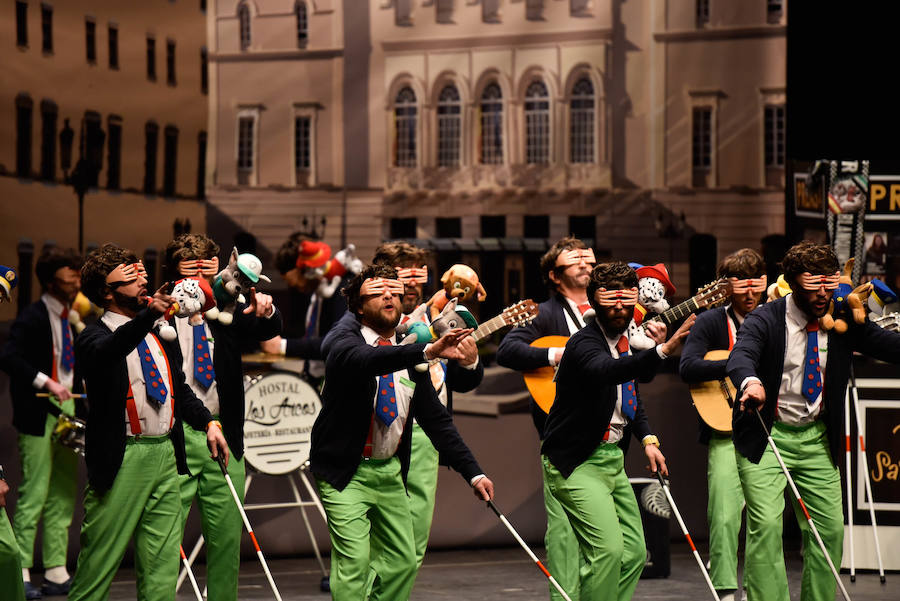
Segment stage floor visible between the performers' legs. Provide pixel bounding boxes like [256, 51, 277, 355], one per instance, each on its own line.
[95, 544, 888, 601]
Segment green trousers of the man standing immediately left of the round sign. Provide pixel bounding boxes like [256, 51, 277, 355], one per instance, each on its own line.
[178, 420, 244, 601]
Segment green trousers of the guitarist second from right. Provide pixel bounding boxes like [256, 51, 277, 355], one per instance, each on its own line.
[706, 433, 744, 590]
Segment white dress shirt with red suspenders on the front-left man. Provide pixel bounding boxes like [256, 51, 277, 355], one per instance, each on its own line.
[100, 311, 174, 436]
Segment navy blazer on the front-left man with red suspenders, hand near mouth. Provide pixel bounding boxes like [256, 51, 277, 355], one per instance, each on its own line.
[75, 308, 212, 492]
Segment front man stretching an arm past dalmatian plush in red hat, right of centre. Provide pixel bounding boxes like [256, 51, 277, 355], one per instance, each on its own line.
[541, 261, 694, 601]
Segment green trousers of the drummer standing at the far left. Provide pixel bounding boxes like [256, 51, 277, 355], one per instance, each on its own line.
[12, 399, 78, 569]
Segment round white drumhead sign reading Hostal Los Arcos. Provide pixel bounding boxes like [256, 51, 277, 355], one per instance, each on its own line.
[244, 372, 322, 475]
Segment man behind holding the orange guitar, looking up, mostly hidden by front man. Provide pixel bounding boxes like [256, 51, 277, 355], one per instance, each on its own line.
[497, 236, 594, 601]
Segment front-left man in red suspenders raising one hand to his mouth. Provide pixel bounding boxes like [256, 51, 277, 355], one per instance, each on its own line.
[69, 244, 228, 601]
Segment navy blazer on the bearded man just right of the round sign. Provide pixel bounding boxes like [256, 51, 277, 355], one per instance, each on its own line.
[309, 318, 483, 490]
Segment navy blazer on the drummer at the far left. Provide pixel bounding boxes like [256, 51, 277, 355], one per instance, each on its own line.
[0, 299, 87, 436]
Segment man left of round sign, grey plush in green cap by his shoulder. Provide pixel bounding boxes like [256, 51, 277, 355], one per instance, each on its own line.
[165, 234, 281, 601]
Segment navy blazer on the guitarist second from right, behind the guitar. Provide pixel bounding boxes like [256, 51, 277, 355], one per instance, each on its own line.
[678, 307, 728, 444]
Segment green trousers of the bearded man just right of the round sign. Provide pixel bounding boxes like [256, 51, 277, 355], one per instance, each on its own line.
[316, 457, 416, 601]
